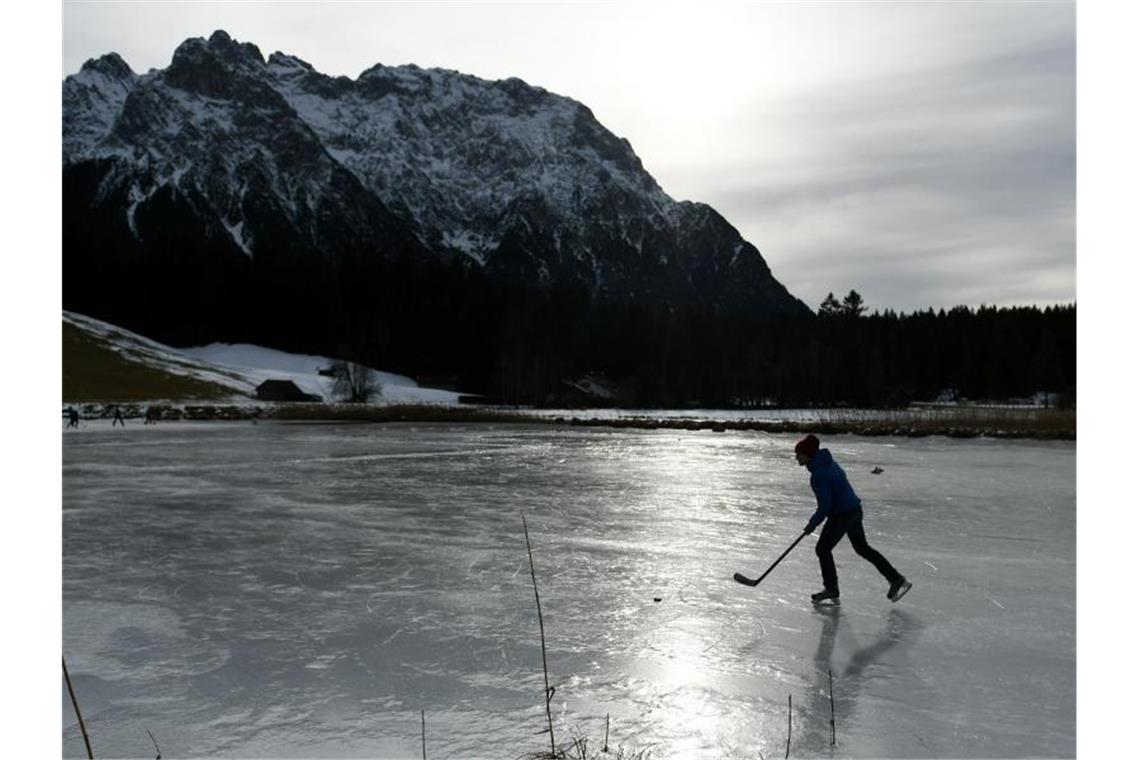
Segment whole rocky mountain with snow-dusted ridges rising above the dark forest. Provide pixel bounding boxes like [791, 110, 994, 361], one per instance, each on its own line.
[63, 31, 806, 348]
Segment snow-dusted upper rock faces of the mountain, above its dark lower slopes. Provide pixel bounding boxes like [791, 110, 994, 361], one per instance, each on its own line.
[64, 33, 675, 254]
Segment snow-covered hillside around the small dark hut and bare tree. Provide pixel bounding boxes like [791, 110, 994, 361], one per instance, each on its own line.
[63, 311, 459, 403]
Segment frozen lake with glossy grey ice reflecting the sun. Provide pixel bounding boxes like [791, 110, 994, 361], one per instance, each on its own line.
[62, 422, 1076, 759]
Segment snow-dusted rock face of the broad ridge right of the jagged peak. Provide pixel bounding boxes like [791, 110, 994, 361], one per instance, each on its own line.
[269, 59, 677, 244]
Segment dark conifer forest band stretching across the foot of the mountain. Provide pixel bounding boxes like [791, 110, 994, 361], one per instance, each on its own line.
[63, 185, 1076, 407]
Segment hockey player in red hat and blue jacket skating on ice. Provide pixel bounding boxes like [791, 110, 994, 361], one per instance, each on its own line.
[796, 435, 911, 603]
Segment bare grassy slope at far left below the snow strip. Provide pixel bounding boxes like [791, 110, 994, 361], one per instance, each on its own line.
[63, 322, 240, 403]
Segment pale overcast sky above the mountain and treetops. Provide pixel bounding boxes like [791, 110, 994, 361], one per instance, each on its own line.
[62, 1, 1076, 311]
